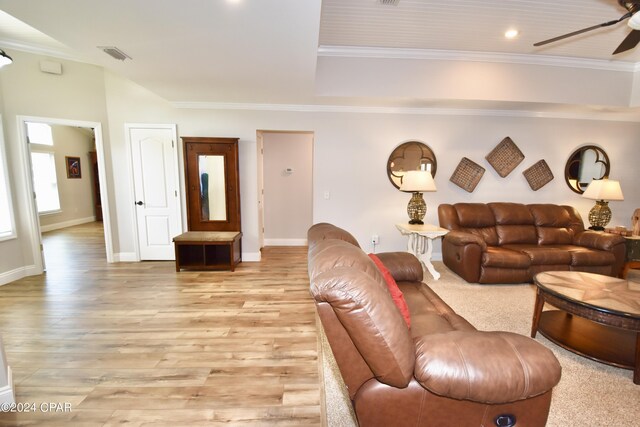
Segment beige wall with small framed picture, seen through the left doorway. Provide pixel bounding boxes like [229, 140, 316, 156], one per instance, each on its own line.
[31, 125, 95, 231]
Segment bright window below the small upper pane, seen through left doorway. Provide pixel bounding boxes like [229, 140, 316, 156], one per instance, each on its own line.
[31, 152, 60, 214]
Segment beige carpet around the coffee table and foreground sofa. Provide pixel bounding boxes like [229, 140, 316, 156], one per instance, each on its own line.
[321, 263, 640, 427]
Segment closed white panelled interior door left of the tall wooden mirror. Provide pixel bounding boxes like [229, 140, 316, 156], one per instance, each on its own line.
[128, 125, 182, 260]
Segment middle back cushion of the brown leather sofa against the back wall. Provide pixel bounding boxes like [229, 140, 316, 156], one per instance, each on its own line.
[488, 203, 538, 245]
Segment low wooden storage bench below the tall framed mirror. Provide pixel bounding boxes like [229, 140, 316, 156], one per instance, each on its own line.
[173, 231, 242, 271]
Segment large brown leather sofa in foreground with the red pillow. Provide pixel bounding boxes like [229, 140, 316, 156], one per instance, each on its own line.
[308, 223, 561, 427]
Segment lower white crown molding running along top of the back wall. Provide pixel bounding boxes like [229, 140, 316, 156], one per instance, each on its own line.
[170, 102, 640, 122]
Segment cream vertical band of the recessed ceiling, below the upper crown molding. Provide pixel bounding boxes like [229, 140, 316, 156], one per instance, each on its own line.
[316, 55, 637, 107]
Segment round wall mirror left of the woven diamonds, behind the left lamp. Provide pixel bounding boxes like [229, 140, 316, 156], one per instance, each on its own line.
[387, 141, 438, 189]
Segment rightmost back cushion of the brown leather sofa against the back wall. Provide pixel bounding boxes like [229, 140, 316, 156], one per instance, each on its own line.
[529, 204, 582, 245]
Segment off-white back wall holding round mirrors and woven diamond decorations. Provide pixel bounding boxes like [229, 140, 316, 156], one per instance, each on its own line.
[100, 74, 640, 255]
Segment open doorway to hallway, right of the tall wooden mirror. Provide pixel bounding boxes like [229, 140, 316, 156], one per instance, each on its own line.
[257, 130, 314, 247]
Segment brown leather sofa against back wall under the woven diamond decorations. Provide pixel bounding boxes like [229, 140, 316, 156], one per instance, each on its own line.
[438, 203, 625, 283]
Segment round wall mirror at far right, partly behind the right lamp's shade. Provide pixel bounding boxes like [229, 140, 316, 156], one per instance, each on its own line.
[564, 145, 610, 194]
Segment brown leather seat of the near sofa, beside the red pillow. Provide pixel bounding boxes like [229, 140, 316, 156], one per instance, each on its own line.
[398, 282, 476, 338]
